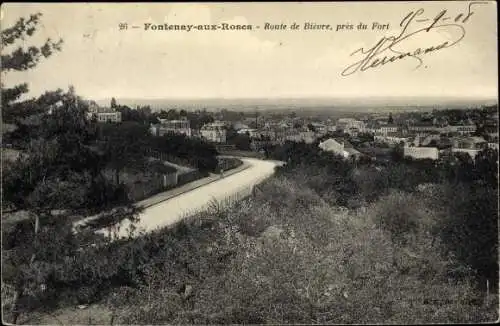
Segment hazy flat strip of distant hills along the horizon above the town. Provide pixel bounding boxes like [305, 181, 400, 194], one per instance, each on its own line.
[96, 97, 498, 112]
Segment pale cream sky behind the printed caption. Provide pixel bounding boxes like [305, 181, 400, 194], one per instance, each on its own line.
[1, 1, 498, 99]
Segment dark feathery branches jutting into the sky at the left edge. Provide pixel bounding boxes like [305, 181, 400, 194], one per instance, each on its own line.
[1, 13, 62, 122]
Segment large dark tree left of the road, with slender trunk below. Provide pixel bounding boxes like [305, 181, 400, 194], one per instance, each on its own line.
[2, 92, 124, 321]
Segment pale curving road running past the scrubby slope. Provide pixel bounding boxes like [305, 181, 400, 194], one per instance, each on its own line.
[98, 157, 282, 237]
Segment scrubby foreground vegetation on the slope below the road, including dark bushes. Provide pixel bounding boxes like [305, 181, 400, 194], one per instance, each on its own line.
[2, 144, 498, 324]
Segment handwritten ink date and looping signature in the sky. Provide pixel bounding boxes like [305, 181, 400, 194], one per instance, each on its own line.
[341, 2, 487, 76]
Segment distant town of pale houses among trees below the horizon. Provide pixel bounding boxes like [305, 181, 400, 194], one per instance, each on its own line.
[84, 99, 498, 161]
